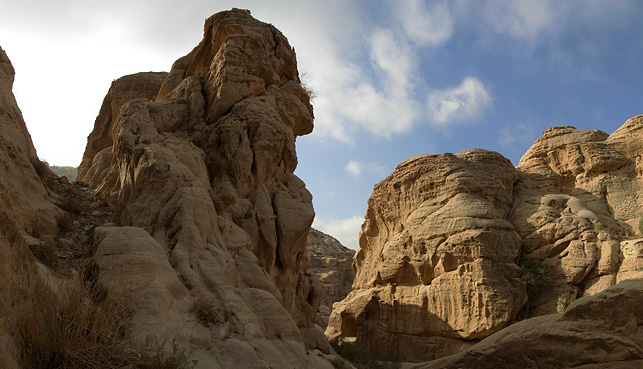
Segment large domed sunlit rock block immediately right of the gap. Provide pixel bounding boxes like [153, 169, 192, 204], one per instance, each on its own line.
[326, 149, 526, 361]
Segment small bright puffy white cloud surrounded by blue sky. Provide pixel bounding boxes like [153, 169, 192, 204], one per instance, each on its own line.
[428, 77, 493, 126]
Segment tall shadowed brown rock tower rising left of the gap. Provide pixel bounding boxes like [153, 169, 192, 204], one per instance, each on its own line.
[82, 9, 332, 368]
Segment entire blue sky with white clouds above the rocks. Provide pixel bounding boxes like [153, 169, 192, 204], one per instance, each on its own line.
[0, 0, 643, 248]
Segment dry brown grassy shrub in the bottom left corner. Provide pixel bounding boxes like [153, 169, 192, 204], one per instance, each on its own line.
[18, 266, 192, 369]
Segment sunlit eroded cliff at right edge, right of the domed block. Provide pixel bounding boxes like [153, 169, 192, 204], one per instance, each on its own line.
[509, 121, 643, 316]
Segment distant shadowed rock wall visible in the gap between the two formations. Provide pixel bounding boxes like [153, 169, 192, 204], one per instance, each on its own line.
[306, 228, 355, 329]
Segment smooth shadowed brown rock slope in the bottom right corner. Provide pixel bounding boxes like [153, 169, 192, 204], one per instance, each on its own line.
[416, 279, 643, 369]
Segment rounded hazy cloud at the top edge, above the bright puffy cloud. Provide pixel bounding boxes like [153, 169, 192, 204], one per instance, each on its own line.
[394, 0, 453, 47]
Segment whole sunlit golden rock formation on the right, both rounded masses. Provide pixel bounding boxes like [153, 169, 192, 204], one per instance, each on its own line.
[326, 116, 643, 361]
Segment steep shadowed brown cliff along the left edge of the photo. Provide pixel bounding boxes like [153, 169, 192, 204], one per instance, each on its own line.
[0, 48, 63, 369]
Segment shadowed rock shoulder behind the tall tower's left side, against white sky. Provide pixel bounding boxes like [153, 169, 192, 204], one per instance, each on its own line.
[77, 72, 168, 183]
